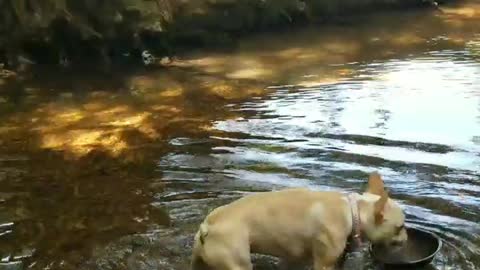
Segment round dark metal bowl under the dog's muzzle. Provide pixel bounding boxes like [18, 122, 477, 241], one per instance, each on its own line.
[370, 228, 442, 268]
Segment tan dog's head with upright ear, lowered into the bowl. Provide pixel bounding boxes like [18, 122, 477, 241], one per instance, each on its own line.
[362, 173, 408, 246]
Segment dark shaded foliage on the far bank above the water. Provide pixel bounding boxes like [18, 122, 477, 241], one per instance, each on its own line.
[0, 0, 436, 67]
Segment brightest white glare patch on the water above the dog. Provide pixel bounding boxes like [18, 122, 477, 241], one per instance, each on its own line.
[217, 54, 480, 170]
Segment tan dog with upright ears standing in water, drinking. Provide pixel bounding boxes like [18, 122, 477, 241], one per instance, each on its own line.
[192, 173, 407, 270]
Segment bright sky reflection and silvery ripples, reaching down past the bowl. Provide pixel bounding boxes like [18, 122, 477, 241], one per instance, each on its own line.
[215, 51, 480, 269]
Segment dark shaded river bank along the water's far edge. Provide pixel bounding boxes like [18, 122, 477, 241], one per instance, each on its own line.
[0, 0, 442, 69]
